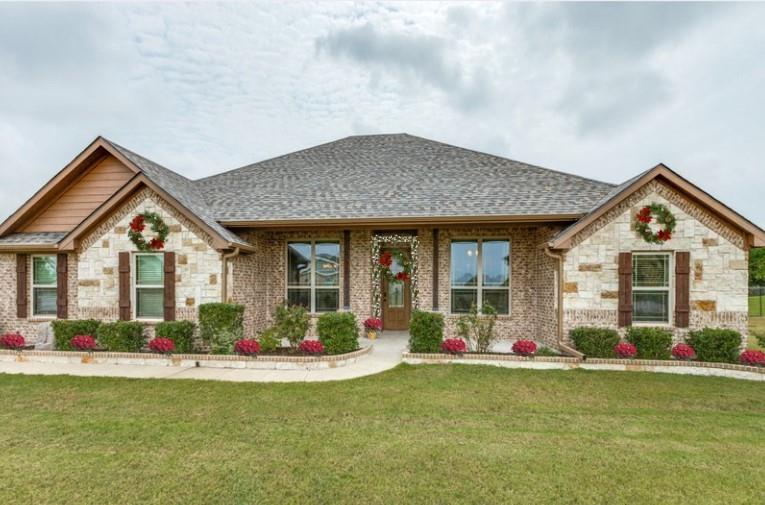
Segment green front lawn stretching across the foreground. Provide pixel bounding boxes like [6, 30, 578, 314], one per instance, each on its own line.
[0, 365, 765, 504]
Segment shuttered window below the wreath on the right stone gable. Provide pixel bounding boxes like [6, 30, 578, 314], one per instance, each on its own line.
[632, 253, 672, 324]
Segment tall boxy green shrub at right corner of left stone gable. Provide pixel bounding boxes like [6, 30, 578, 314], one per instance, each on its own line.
[199, 303, 244, 354]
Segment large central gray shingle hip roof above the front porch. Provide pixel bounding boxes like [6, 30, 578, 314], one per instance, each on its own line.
[194, 134, 614, 221]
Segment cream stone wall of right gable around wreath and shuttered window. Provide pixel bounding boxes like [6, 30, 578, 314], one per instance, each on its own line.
[564, 181, 748, 340]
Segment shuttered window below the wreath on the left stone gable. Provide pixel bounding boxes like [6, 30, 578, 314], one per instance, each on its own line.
[133, 254, 165, 319]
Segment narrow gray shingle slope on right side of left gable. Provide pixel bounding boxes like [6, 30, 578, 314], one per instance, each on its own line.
[104, 139, 247, 245]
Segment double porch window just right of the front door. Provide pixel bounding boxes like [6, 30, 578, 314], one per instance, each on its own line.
[451, 239, 510, 314]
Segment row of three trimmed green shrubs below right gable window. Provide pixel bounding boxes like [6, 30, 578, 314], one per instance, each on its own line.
[570, 326, 741, 363]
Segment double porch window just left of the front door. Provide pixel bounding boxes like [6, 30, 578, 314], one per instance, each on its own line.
[287, 241, 340, 312]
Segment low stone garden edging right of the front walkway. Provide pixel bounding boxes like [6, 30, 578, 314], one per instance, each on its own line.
[403, 352, 765, 381]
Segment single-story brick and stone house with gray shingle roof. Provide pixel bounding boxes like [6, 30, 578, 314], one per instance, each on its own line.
[0, 134, 765, 349]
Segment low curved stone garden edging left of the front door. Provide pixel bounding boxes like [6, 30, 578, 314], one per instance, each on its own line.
[0, 346, 372, 370]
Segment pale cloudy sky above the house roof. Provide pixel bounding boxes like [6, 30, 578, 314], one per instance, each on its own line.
[0, 2, 765, 225]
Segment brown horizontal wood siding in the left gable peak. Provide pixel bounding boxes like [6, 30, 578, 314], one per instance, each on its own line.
[20, 156, 134, 233]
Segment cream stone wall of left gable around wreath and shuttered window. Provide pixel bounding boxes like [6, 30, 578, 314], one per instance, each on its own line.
[76, 190, 222, 320]
